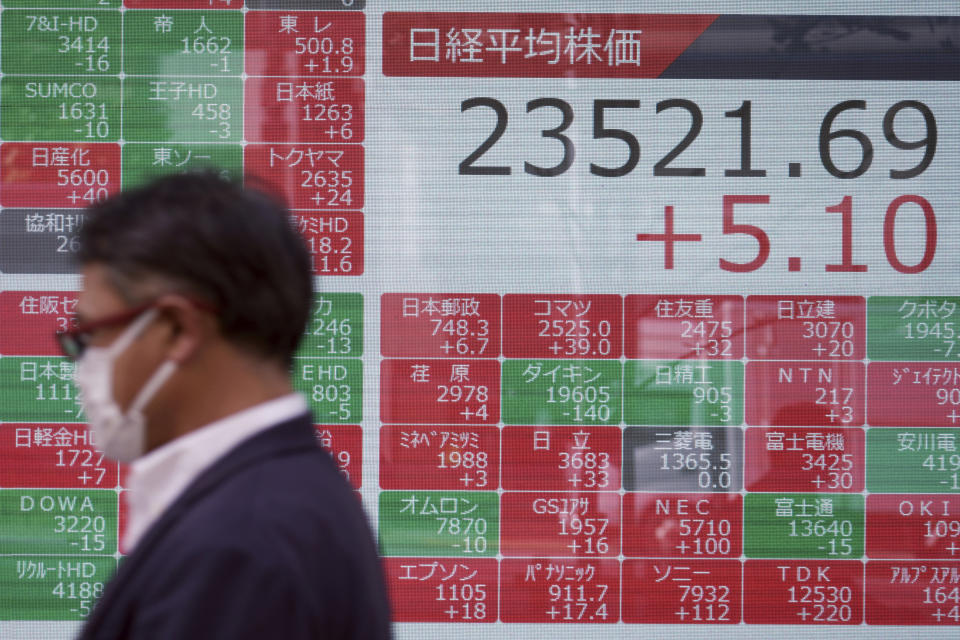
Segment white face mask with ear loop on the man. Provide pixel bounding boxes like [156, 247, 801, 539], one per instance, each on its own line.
[75, 309, 177, 462]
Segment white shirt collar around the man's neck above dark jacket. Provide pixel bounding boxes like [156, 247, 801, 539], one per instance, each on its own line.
[123, 393, 308, 553]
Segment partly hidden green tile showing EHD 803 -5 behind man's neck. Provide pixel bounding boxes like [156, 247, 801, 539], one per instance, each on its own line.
[293, 358, 363, 424]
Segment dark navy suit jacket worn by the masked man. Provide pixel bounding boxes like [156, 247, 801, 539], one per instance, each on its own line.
[80, 414, 390, 640]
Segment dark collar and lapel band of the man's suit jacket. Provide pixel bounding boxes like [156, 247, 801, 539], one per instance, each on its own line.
[86, 414, 317, 629]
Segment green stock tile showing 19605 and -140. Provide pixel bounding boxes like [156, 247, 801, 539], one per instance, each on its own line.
[501, 360, 622, 425]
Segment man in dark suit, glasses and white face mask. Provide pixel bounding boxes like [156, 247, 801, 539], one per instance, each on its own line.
[61, 174, 390, 640]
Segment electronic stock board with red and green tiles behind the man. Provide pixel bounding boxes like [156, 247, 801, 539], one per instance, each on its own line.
[0, 0, 960, 638]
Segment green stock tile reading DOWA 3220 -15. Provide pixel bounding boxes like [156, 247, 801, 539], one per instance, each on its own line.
[0, 489, 119, 556]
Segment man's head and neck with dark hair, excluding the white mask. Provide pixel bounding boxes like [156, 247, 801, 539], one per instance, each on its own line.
[71, 173, 312, 458]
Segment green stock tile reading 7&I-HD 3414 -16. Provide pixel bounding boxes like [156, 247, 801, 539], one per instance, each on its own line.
[0, 9, 122, 75]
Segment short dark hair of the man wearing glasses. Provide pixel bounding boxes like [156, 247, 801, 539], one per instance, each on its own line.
[77, 173, 311, 366]
